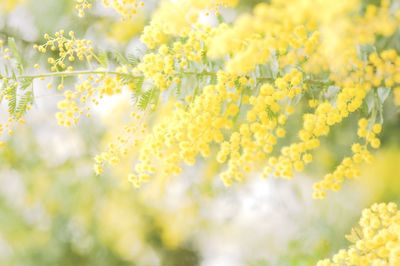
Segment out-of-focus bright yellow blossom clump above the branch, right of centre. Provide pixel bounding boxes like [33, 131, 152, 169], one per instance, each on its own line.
[207, 20, 319, 74]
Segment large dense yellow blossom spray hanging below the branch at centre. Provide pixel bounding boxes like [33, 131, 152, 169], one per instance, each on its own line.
[126, 72, 248, 186]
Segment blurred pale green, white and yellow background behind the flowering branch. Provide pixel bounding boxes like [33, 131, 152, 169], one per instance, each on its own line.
[0, 0, 400, 266]
